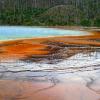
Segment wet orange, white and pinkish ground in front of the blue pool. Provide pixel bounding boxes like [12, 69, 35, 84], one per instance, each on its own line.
[0, 28, 100, 100]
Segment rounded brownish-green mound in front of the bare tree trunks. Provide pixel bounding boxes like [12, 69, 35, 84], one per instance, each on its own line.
[40, 5, 82, 25]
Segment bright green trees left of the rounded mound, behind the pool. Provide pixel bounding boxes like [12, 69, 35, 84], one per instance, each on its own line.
[0, 8, 45, 25]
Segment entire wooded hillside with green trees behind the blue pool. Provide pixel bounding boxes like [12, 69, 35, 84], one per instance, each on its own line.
[0, 0, 100, 27]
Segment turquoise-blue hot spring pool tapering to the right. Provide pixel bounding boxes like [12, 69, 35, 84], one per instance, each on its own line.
[0, 26, 89, 40]
